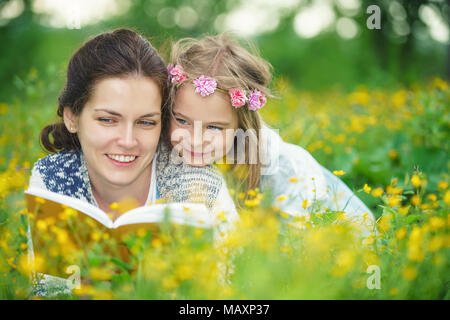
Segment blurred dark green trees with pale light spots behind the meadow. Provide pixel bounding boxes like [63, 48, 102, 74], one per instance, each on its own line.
[0, 0, 450, 103]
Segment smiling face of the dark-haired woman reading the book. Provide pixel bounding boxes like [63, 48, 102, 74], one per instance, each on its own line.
[64, 77, 162, 192]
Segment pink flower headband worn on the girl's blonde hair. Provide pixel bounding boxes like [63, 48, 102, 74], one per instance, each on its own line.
[167, 64, 267, 111]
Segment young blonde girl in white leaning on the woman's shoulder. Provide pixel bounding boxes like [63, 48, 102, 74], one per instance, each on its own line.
[167, 35, 374, 233]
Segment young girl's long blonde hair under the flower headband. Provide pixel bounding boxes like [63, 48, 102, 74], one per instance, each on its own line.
[165, 33, 272, 190]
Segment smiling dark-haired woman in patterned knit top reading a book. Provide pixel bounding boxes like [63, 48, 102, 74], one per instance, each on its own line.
[29, 29, 237, 295]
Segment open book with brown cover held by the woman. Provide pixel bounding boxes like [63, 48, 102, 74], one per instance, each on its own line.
[25, 187, 214, 275]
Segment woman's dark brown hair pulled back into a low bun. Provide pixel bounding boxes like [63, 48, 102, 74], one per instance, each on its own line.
[40, 29, 168, 152]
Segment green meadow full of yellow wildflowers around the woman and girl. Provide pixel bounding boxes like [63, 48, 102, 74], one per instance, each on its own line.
[0, 69, 450, 299]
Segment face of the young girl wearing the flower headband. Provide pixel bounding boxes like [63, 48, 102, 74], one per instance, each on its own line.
[169, 83, 238, 166]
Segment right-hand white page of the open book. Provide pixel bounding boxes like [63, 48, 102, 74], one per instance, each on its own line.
[113, 203, 214, 228]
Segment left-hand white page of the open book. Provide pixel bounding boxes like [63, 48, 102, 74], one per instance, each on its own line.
[25, 187, 113, 228]
